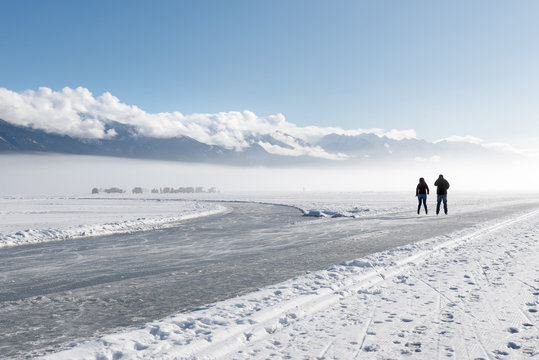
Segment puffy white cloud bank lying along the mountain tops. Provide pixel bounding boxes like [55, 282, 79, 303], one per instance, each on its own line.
[0, 87, 416, 159]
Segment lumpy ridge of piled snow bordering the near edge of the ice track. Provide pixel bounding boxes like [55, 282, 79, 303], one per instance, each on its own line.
[46, 209, 539, 359]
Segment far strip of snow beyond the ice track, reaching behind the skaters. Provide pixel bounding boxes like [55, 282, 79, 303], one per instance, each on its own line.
[0, 192, 535, 248]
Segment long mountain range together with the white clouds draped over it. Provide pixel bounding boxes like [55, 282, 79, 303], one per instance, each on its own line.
[0, 87, 528, 165]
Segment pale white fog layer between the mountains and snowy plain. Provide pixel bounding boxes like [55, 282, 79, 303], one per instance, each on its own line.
[0, 154, 539, 195]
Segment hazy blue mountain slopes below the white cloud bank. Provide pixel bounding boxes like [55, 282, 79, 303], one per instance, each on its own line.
[0, 119, 516, 165]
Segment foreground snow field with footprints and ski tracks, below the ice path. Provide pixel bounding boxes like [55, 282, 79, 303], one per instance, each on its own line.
[46, 209, 539, 359]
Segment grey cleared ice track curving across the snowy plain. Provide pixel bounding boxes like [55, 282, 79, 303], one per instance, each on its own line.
[0, 203, 537, 358]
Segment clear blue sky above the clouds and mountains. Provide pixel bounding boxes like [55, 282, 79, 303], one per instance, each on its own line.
[0, 0, 539, 147]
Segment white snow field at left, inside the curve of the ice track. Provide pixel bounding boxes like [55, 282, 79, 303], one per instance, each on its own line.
[0, 196, 227, 248]
